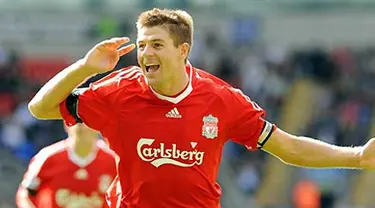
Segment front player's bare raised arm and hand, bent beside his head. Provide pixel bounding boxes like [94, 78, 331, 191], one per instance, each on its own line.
[28, 37, 135, 119]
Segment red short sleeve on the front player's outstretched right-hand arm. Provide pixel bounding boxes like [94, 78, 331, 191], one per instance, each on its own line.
[228, 88, 274, 149]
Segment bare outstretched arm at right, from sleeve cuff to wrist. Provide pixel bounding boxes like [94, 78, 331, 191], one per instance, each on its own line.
[262, 128, 363, 168]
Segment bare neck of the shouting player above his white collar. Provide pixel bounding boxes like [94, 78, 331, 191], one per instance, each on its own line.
[151, 65, 189, 96]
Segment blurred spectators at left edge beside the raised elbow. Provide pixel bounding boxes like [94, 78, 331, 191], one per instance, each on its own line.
[0, 48, 64, 163]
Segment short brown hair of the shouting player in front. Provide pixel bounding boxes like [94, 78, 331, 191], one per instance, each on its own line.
[137, 8, 194, 49]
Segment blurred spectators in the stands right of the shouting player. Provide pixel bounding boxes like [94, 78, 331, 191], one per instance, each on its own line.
[215, 46, 375, 207]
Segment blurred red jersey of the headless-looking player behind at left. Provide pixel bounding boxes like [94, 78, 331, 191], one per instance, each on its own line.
[16, 138, 116, 208]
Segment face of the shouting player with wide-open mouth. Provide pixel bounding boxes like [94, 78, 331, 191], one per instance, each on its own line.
[137, 26, 185, 86]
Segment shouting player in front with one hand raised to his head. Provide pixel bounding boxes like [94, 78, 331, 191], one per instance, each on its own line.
[29, 6, 375, 208]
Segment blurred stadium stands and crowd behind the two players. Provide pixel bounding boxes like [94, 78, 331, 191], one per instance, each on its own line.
[0, 0, 375, 208]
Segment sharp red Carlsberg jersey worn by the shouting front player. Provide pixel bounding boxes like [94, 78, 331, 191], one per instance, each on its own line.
[60, 64, 272, 208]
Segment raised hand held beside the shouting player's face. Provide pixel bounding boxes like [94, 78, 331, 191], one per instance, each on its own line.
[83, 37, 135, 73]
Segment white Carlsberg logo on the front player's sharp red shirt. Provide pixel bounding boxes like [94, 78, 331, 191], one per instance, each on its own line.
[137, 138, 204, 167]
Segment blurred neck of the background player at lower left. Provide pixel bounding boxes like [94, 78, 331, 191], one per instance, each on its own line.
[71, 136, 96, 158]
